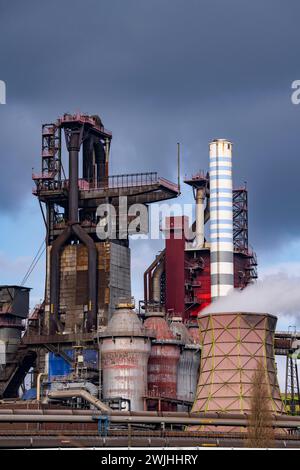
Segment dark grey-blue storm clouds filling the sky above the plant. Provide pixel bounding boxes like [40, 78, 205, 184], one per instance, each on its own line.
[0, 0, 300, 252]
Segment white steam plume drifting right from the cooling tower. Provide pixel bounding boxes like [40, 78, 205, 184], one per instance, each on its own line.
[203, 274, 300, 321]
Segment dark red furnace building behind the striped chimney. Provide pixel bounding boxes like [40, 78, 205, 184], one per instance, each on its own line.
[144, 173, 257, 321]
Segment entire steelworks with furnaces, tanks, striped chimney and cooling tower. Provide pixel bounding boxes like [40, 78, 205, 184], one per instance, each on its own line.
[0, 113, 300, 448]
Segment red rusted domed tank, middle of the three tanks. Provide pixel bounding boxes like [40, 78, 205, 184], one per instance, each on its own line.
[144, 312, 180, 411]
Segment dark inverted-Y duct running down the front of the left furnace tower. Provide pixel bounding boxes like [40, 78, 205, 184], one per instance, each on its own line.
[50, 126, 97, 334]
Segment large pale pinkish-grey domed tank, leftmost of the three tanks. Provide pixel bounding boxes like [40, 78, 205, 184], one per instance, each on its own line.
[100, 303, 151, 411]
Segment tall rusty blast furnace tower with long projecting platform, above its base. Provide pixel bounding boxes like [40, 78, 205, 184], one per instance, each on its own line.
[33, 114, 178, 335]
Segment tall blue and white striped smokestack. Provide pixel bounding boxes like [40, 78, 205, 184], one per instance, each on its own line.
[209, 139, 234, 301]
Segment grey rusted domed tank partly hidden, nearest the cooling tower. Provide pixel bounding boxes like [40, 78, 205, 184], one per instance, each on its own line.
[170, 317, 200, 411]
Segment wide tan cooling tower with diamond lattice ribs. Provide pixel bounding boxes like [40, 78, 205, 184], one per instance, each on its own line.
[192, 312, 284, 426]
